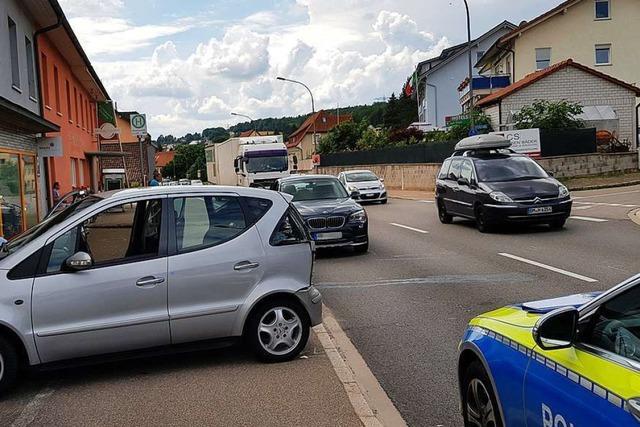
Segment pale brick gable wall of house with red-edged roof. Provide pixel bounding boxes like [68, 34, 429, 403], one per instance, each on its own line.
[500, 67, 637, 147]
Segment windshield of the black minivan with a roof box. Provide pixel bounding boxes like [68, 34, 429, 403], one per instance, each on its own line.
[474, 156, 549, 182]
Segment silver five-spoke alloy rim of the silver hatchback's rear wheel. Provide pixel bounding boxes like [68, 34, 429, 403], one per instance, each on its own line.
[258, 307, 302, 356]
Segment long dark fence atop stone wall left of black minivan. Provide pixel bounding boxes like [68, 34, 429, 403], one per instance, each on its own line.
[320, 141, 458, 166]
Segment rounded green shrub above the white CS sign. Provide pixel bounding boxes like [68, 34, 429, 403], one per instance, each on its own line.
[513, 99, 584, 129]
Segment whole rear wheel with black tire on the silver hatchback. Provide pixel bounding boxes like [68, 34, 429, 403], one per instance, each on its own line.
[245, 299, 310, 363]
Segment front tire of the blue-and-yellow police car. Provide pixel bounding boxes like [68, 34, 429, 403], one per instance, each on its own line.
[462, 360, 503, 427]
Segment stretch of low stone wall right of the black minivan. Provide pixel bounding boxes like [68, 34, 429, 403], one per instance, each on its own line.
[538, 152, 638, 178]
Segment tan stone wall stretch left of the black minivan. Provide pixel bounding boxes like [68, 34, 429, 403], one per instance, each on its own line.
[316, 163, 440, 191]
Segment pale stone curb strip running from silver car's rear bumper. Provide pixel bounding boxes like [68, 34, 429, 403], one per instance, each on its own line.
[313, 306, 407, 427]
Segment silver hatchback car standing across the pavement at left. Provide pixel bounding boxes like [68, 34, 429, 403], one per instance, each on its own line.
[0, 186, 322, 392]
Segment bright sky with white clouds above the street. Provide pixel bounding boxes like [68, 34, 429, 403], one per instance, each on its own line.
[60, 0, 559, 135]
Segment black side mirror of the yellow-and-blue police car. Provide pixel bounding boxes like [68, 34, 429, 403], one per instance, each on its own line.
[532, 307, 579, 350]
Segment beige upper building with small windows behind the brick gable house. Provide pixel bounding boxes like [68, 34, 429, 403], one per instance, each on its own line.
[477, 0, 640, 85]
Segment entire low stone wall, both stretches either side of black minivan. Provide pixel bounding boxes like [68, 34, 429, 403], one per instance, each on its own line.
[316, 152, 638, 191]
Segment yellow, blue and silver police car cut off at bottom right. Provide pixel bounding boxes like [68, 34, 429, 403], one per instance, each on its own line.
[458, 275, 640, 427]
